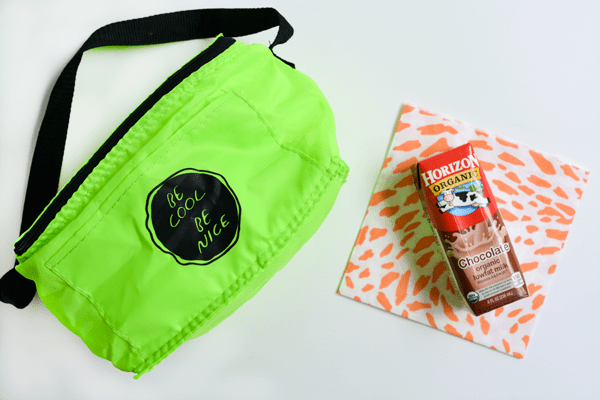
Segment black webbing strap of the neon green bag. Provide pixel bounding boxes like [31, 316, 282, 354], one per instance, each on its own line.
[0, 8, 294, 308]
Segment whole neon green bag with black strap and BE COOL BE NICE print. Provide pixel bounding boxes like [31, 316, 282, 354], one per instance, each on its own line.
[0, 8, 348, 376]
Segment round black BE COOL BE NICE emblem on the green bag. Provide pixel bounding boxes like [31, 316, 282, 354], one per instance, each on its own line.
[146, 168, 242, 265]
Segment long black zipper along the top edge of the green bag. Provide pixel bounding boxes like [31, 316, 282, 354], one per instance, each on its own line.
[15, 37, 235, 256]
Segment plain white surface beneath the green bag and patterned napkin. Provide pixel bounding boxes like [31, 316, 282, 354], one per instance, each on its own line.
[0, 0, 600, 400]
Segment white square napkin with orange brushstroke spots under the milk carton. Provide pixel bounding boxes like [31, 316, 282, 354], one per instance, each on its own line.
[338, 105, 589, 358]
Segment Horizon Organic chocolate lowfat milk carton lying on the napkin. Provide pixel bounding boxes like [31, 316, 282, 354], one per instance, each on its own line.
[412, 143, 529, 315]
